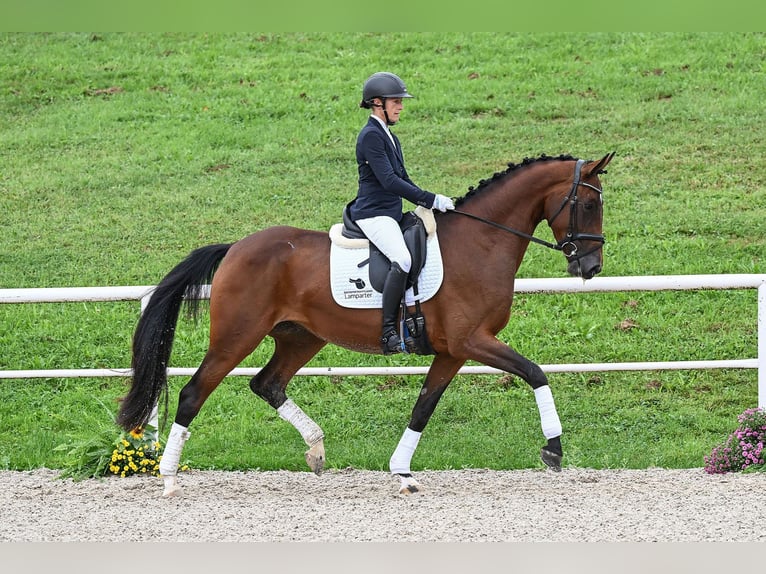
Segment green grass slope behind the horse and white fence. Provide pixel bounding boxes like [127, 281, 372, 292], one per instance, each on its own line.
[0, 33, 766, 470]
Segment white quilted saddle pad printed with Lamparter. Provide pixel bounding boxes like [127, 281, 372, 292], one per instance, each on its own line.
[330, 223, 444, 309]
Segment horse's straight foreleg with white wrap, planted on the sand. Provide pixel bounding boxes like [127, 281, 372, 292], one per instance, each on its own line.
[389, 355, 464, 494]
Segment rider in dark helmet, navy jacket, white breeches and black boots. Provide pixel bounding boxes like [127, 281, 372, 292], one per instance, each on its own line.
[349, 72, 455, 355]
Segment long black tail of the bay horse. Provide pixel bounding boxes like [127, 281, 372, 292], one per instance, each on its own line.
[117, 244, 232, 431]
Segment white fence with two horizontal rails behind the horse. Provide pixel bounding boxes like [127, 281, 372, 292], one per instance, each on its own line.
[0, 274, 766, 408]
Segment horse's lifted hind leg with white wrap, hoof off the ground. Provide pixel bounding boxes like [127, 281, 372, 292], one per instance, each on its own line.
[250, 323, 326, 474]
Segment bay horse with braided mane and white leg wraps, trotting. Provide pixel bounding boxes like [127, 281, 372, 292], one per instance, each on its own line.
[116, 152, 614, 496]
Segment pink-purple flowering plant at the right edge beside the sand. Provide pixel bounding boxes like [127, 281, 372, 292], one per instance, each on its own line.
[705, 407, 766, 474]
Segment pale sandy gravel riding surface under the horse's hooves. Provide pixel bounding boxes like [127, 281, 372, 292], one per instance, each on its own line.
[0, 468, 766, 542]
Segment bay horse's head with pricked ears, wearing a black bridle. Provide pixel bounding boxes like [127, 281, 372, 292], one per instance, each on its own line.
[545, 152, 615, 279]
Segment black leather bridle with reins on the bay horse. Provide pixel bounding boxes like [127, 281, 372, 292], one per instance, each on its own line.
[448, 159, 606, 261]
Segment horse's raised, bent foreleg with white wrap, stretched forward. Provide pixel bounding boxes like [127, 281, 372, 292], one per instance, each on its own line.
[470, 336, 563, 472]
